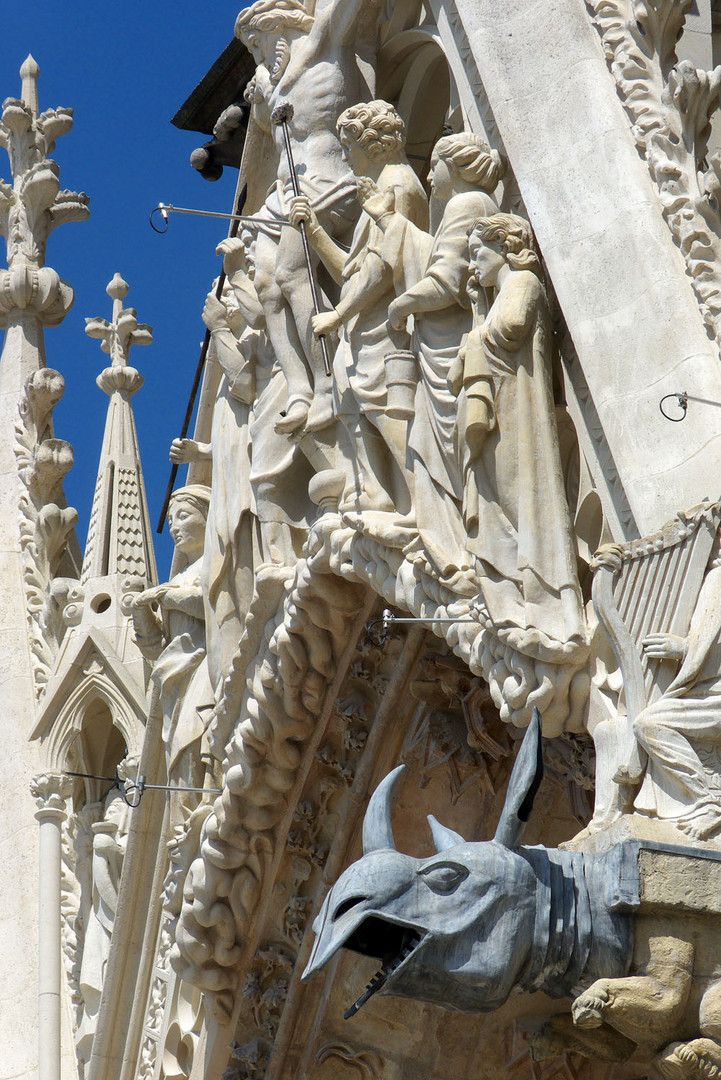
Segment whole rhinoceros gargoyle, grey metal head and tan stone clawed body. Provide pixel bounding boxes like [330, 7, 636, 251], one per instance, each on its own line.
[303, 710, 721, 1077]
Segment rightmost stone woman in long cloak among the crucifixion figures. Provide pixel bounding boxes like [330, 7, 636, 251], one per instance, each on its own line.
[451, 214, 584, 659]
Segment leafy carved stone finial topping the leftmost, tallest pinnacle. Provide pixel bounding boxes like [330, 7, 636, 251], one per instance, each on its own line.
[0, 56, 90, 326]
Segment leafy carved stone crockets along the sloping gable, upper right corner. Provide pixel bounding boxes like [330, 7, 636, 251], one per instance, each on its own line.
[586, 0, 721, 338]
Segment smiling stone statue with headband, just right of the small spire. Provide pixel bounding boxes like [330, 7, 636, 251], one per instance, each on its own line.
[133, 484, 214, 786]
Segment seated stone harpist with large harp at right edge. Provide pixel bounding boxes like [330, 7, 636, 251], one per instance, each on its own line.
[589, 503, 721, 840]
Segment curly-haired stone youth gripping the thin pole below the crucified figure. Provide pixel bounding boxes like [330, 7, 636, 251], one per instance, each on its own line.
[290, 102, 428, 514]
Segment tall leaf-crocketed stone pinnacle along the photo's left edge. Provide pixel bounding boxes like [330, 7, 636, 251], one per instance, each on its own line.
[0, 56, 89, 1080]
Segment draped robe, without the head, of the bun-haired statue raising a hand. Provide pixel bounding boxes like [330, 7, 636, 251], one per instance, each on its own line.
[383, 191, 498, 577]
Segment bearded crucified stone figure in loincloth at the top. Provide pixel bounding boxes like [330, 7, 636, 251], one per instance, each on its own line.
[235, 0, 378, 433]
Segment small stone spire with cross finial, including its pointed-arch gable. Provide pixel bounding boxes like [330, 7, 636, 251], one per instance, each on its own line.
[32, 273, 158, 772]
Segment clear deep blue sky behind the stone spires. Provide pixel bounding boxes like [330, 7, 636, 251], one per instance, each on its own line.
[0, 0, 244, 580]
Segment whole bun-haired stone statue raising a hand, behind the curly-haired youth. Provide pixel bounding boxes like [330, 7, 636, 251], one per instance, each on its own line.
[358, 132, 505, 594]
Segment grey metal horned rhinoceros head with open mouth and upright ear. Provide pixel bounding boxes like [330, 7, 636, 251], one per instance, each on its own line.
[303, 708, 543, 1017]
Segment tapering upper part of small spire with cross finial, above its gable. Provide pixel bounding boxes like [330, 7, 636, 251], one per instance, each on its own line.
[81, 273, 158, 588]
